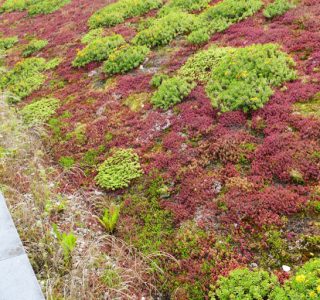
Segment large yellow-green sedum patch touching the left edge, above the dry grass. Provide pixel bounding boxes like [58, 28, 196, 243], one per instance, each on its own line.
[0, 57, 59, 103]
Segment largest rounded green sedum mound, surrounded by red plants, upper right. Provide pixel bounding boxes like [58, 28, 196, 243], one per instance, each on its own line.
[154, 44, 296, 112]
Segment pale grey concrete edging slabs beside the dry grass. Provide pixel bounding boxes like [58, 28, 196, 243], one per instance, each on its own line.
[0, 193, 45, 300]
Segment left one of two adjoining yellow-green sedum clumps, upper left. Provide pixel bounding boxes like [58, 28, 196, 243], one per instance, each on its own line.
[72, 34, 125, 67]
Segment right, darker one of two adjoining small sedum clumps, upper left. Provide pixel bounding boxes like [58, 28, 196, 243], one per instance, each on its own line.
[103, 45, 150, 75]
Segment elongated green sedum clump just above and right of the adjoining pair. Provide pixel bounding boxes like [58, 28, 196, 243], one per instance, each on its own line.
[132, 11, 197, 48]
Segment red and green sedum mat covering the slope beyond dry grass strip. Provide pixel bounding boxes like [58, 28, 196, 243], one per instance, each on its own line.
[0, 0, 320, 300]
